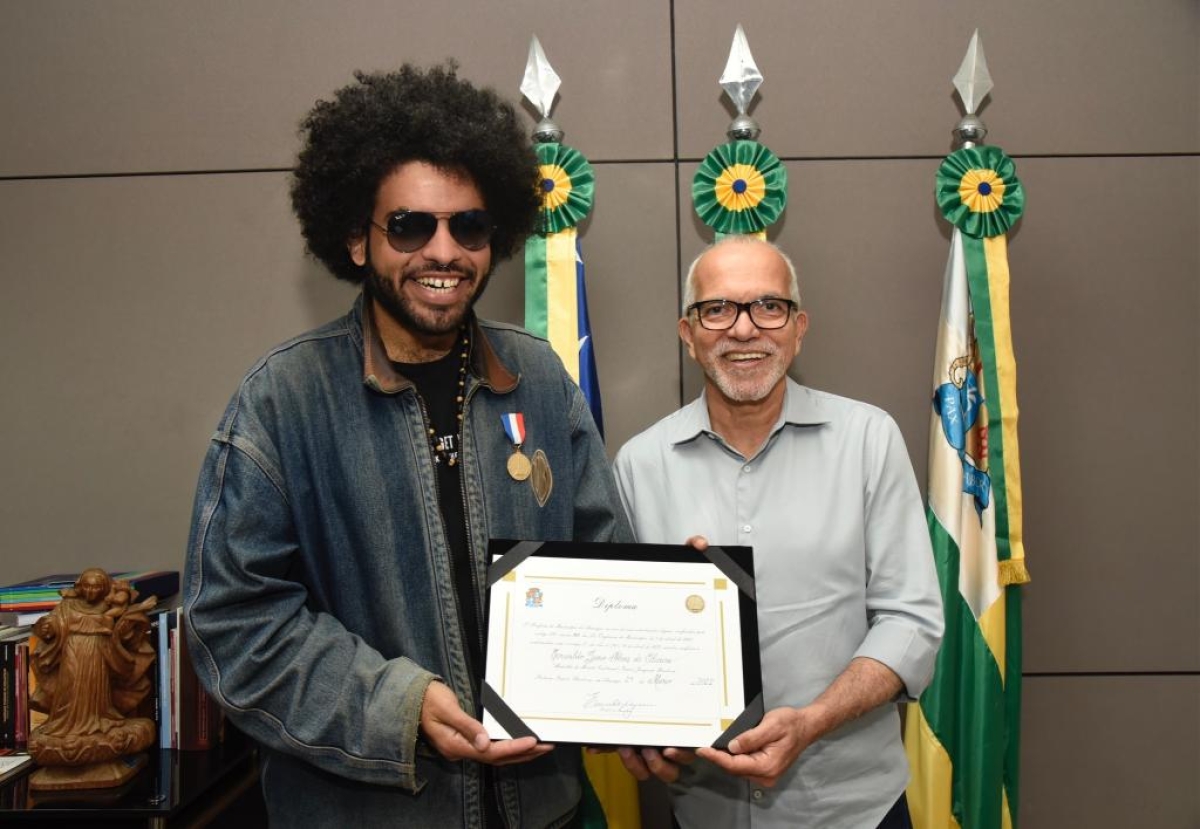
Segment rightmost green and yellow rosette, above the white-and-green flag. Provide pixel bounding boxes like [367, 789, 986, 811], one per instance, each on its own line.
[935, 146, 1025, 239]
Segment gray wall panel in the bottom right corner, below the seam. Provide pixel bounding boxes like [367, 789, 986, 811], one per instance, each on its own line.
[1021, 675, 1200, 829]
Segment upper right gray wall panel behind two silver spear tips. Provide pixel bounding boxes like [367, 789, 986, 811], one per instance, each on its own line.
[676, 0, 1200, 157]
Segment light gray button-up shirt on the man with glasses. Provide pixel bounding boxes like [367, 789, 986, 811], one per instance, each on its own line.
[616, 379, 942, 829]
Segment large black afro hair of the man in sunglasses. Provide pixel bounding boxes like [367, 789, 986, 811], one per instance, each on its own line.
[292, 61, 540, 283]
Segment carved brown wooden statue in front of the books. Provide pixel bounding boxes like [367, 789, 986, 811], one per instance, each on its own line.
[29, 567, 157, 791]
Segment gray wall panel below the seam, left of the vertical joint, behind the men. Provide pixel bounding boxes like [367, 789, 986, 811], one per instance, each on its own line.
[0, 164, 679, 578]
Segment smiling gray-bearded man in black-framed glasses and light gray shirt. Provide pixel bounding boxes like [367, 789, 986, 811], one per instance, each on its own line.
[616, 236, 943, 829]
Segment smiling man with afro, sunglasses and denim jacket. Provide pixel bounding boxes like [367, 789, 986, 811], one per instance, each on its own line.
[184, 66, 630, 829]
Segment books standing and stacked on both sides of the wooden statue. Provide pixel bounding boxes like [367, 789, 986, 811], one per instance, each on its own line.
[0, 570, 224, 756]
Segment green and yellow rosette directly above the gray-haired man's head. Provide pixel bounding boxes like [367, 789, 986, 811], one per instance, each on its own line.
[691, 140, 787, 235]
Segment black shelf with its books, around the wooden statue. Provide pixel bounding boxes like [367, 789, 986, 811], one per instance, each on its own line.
[0, 571, 265, 829]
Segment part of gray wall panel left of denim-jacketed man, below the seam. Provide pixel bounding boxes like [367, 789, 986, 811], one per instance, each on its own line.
[0, 174, 353, 582]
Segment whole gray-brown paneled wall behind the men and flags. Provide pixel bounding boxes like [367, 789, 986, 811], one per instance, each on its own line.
[0, 0, 1200, 829]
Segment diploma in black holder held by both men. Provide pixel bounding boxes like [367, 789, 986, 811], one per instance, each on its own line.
[481, 541, 762, 747]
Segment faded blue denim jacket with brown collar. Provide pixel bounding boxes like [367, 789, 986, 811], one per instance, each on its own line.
[184, 296, 631, 829]
